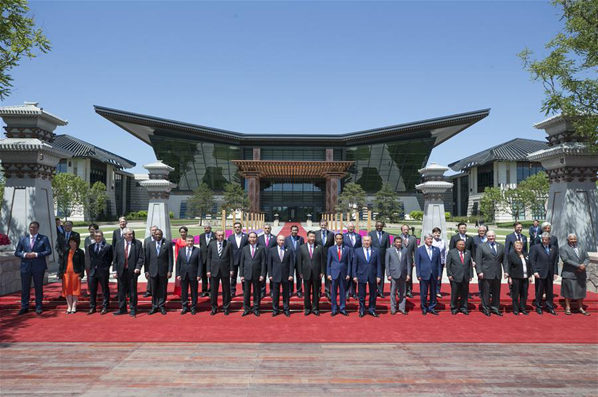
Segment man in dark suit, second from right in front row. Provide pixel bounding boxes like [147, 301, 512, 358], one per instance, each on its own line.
[529, 233, 559, 316]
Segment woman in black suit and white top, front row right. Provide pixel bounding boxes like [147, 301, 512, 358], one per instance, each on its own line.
[507, 241, 533, 316]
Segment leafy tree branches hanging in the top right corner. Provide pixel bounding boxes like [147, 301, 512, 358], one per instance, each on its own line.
[519, 0, 598, 152]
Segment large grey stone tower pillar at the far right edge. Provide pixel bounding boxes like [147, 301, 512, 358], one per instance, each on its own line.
[528, 116, 598, 252]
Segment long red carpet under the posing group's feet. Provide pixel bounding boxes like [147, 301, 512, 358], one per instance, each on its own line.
[0, 283, 598, 344]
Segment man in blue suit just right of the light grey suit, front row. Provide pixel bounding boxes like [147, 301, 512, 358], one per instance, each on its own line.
[415, 234, 442, 316]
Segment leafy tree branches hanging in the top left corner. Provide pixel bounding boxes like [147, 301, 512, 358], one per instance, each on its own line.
[0, 0, 51, 101]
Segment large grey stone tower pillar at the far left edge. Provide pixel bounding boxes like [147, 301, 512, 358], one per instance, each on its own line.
[0, 102, 71, 263]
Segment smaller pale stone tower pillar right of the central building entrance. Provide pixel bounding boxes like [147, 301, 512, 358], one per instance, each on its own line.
[415, 163, 453, 241]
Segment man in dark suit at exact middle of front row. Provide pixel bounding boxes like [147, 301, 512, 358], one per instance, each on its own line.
[297, 230, 326, 316]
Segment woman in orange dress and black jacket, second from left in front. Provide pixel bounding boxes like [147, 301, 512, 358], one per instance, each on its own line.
[58, 237, 85, 314]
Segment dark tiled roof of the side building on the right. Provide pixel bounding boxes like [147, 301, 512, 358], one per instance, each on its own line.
[449, 138, 548, 171]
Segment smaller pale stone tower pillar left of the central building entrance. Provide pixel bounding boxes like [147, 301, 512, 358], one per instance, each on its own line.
[140, 161, 176, 241]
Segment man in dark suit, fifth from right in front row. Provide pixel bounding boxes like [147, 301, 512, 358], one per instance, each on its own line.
[446, 240, 473, 315]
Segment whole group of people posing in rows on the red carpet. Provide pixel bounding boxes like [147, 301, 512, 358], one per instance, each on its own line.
[15, 218, 589, 317]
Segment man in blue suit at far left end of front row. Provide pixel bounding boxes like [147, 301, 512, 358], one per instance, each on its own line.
[15, 221, 52, 315]
